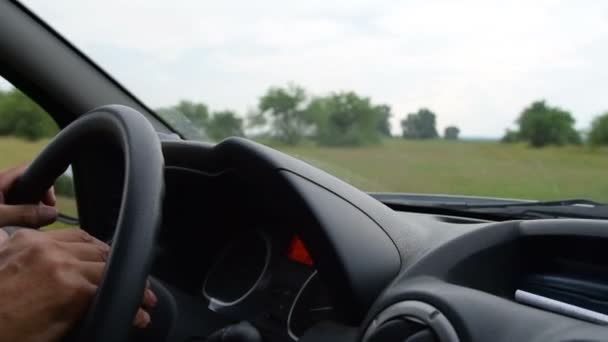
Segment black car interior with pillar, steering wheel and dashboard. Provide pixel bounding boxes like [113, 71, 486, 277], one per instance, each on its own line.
[0, 1, 608, 342]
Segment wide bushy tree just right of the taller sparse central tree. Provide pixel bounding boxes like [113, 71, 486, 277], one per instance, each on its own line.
[306, 92, 382, 146]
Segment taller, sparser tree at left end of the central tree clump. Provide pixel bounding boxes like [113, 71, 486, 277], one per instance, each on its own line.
[252, 84, 310, 145]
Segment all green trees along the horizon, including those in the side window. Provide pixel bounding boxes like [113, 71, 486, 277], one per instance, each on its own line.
[0, 84, 608, 147]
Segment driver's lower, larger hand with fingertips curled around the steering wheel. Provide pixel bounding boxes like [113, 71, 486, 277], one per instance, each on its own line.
[0, 229, 156, 342]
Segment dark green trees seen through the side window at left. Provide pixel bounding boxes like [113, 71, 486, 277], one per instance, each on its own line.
[0, 89, 59, 140]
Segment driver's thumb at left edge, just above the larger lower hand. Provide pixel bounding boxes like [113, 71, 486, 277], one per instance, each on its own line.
[0, 204, 57, 228]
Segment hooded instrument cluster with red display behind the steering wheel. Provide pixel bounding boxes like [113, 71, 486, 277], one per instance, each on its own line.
[142, 142, 400, 341]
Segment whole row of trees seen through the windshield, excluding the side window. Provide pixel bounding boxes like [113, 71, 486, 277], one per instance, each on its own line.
[154, 84, 608, 147]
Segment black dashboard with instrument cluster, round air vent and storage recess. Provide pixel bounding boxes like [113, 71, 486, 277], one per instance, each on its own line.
[137, 139, 608, 341]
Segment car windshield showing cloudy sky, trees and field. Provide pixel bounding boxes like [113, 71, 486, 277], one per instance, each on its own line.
[25, 0, 608, 202]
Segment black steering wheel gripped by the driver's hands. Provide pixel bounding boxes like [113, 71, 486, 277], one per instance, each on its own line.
[7, 105, 164, 342]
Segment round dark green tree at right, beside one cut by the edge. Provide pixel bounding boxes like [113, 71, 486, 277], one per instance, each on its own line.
[517, 101, 581, 147]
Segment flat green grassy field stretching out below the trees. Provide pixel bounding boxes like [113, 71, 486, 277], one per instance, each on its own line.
[0, 138, 608, 209]
